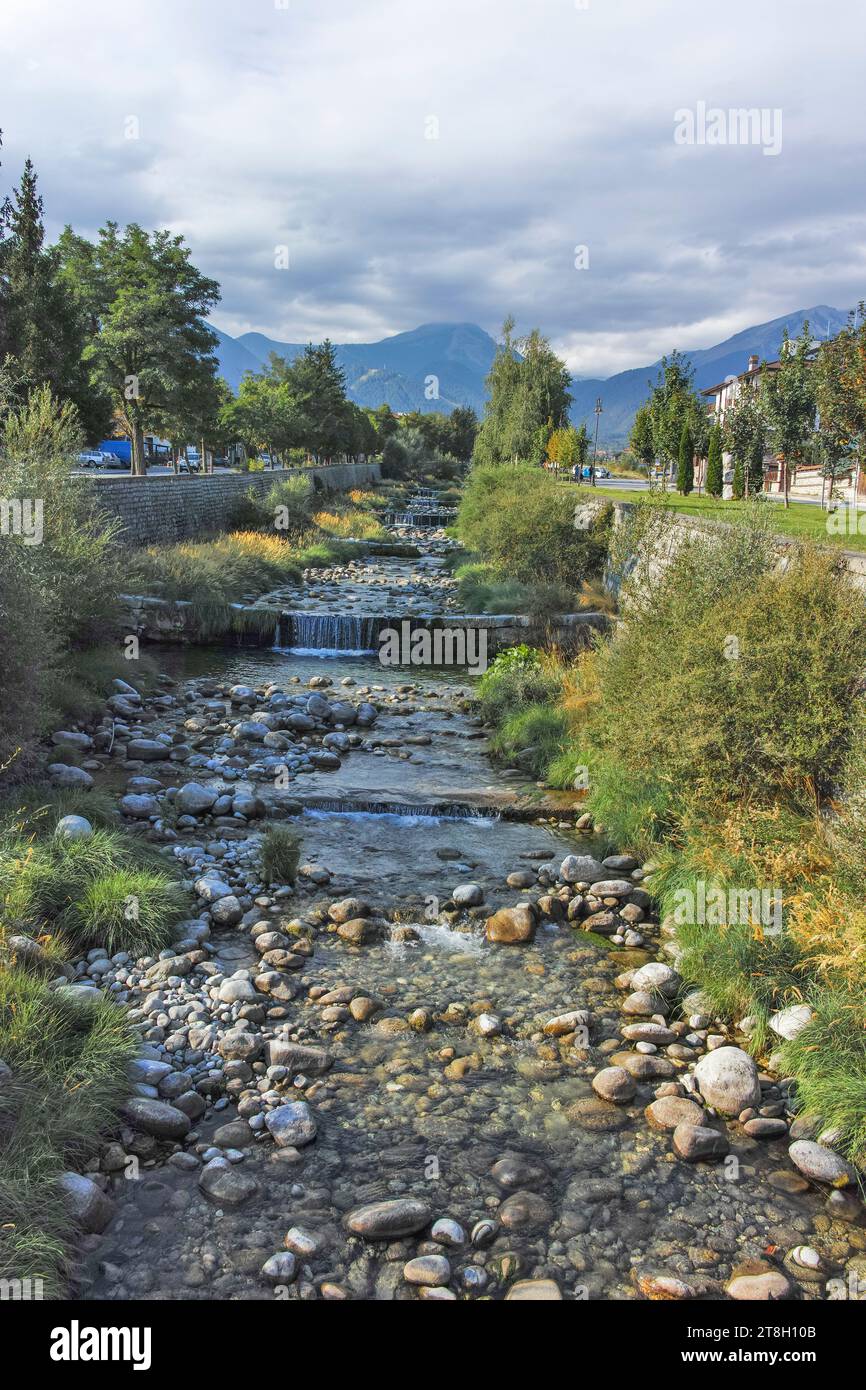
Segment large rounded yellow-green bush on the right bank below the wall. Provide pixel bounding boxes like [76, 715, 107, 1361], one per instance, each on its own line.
[591, 527, 866, 803]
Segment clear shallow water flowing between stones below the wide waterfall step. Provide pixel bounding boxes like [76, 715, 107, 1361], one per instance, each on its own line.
[81, 556, 863, 1300]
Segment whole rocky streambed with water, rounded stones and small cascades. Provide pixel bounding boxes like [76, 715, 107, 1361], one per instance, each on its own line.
[50, 509, 866, 1301]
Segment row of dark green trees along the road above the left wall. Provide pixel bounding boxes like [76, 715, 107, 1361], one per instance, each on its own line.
[0, 140, 477, 474]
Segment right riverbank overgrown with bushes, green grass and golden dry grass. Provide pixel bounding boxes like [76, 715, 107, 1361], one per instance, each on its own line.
[481, 509, 866, 1163]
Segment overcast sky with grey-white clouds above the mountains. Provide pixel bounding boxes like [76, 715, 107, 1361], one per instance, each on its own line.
[0, 0, 866, 375]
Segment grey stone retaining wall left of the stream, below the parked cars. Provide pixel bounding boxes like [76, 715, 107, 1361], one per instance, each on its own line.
[90, 463, 381, 545]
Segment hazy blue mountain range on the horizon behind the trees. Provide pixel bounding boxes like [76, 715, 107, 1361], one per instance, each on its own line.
[210, 304, 848, 446]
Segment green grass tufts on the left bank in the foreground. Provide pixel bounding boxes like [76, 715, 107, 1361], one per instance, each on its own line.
[0, 787, 186, 1297]
